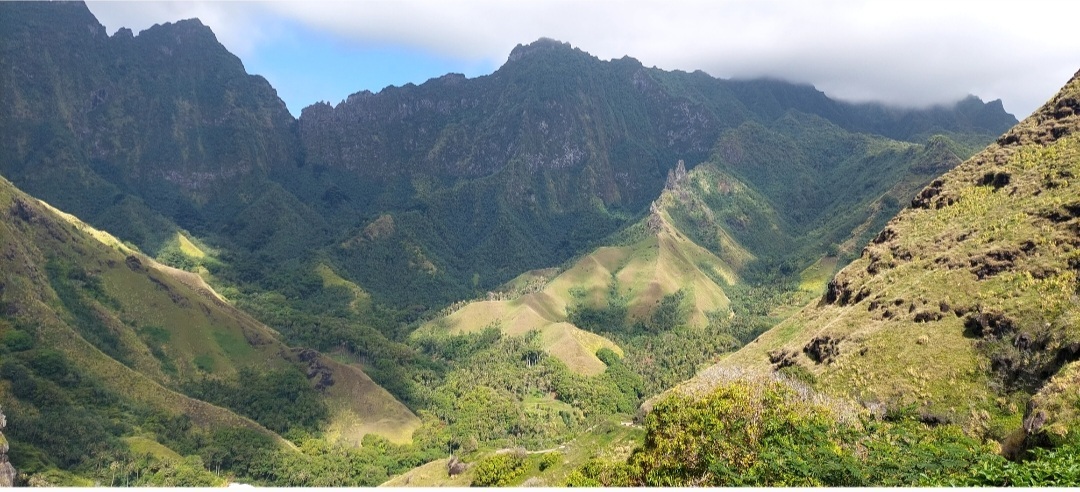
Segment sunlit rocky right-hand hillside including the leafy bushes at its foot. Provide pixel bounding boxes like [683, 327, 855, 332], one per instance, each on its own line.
[566, 72, 1080, 487]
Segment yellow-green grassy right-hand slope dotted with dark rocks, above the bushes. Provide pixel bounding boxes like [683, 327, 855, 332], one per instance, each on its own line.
[686, 70, 1080, 443]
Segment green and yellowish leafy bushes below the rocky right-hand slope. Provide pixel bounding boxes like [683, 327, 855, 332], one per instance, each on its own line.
[567, 380, 1080, 487]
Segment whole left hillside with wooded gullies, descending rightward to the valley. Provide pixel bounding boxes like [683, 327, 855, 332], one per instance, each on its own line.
[0, 173, 419, 481]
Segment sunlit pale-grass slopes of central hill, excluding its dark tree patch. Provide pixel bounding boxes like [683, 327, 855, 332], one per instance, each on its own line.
[422, 179, 737, 374]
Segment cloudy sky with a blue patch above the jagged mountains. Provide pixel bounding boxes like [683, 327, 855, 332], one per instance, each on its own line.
[86, 0, 1080, 119]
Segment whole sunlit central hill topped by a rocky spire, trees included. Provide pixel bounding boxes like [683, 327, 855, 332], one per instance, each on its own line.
[420, 165, 745, 375]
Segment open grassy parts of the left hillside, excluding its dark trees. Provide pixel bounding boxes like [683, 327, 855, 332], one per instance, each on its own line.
[0, 181, 419, 441]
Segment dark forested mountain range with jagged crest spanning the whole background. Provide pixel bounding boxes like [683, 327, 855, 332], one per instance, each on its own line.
[0, 2, 1015, 315]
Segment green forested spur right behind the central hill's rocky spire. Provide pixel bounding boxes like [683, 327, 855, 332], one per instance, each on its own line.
[672, 110, 968, 271]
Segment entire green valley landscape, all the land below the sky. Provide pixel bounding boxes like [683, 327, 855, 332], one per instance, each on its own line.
[0, 2, 1080, 487]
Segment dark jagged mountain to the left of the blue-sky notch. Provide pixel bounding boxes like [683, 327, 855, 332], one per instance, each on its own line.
[0, 2, 300, 250]
